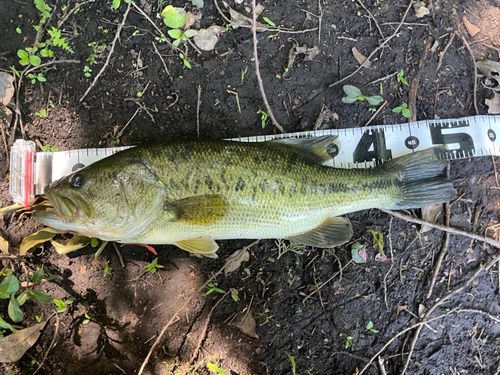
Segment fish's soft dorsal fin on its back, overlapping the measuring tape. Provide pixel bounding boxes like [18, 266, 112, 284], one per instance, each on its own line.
[266, 135, 340, 164]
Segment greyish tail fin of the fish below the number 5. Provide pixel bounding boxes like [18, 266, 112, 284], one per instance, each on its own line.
[381, 146, 455, 209]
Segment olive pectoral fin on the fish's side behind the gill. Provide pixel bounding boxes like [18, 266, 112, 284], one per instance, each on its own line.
[163, 194, 229, 225]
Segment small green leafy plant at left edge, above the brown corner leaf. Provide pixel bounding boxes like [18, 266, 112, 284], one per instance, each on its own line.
[0, 267, 53, 332]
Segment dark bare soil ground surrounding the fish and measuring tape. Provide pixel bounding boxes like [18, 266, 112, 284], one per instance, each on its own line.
[0, 0, 500, 375]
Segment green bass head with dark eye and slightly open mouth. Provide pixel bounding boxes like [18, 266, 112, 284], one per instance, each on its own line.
[34, 157, 164, 241]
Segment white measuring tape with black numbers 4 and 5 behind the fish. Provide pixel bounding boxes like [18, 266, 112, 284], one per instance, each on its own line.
[9, 116, 500, 207]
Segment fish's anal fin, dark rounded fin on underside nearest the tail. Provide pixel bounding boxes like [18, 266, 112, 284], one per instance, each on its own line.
[288, 217, 352, 247]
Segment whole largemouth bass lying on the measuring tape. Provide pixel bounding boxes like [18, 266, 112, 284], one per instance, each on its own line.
[34, 136, 454, 257]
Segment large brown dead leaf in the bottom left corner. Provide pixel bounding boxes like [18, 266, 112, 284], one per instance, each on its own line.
[0, 322, 46, 363]
